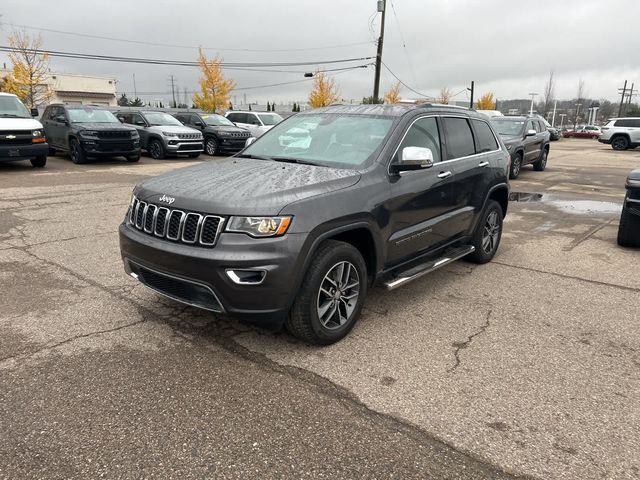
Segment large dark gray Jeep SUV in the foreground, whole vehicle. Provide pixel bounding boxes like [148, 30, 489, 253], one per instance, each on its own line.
[120, 105, 509, 344]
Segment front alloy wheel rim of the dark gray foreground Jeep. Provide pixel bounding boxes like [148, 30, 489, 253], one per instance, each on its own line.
[317, 261, 360, 330]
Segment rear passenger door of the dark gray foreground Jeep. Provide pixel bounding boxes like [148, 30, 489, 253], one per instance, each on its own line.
[444, 118, 502, 236]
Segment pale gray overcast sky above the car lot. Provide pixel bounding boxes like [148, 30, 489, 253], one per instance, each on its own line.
[0, 0, 640, 103]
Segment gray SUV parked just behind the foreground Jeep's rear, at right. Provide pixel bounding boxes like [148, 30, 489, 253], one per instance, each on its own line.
[491, 116, 551, 179]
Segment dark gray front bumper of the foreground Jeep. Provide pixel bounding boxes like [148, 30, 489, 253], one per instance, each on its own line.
[119, 223, 306, 325]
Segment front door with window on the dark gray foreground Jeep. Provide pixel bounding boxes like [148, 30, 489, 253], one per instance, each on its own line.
[385, 117, 455, 268]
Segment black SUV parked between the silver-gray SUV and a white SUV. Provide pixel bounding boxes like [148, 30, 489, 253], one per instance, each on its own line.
[174, 112, 251, 155]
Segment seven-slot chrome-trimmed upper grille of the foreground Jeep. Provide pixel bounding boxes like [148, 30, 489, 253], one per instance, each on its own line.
[129, 197, 224, 247]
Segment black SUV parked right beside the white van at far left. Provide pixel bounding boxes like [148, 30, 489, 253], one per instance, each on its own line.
[41, 104, 140, 163]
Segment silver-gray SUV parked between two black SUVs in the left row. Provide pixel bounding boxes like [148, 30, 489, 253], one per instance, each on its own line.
[116, 110, 203, 159]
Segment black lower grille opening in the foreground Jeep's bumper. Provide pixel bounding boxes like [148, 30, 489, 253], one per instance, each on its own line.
[130, 264, 223, 312]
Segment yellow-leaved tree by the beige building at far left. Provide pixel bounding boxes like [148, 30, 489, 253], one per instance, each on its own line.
[3, 30, 51, 108]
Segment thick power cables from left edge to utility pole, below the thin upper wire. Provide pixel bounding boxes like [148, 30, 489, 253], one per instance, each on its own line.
[0, 45, 375, 68]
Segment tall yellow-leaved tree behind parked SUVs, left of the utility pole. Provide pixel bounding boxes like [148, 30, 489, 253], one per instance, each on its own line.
[193, 49, 236, 113]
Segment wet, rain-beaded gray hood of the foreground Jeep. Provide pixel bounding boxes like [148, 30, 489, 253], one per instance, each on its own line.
[136, 157, 360, 215]
